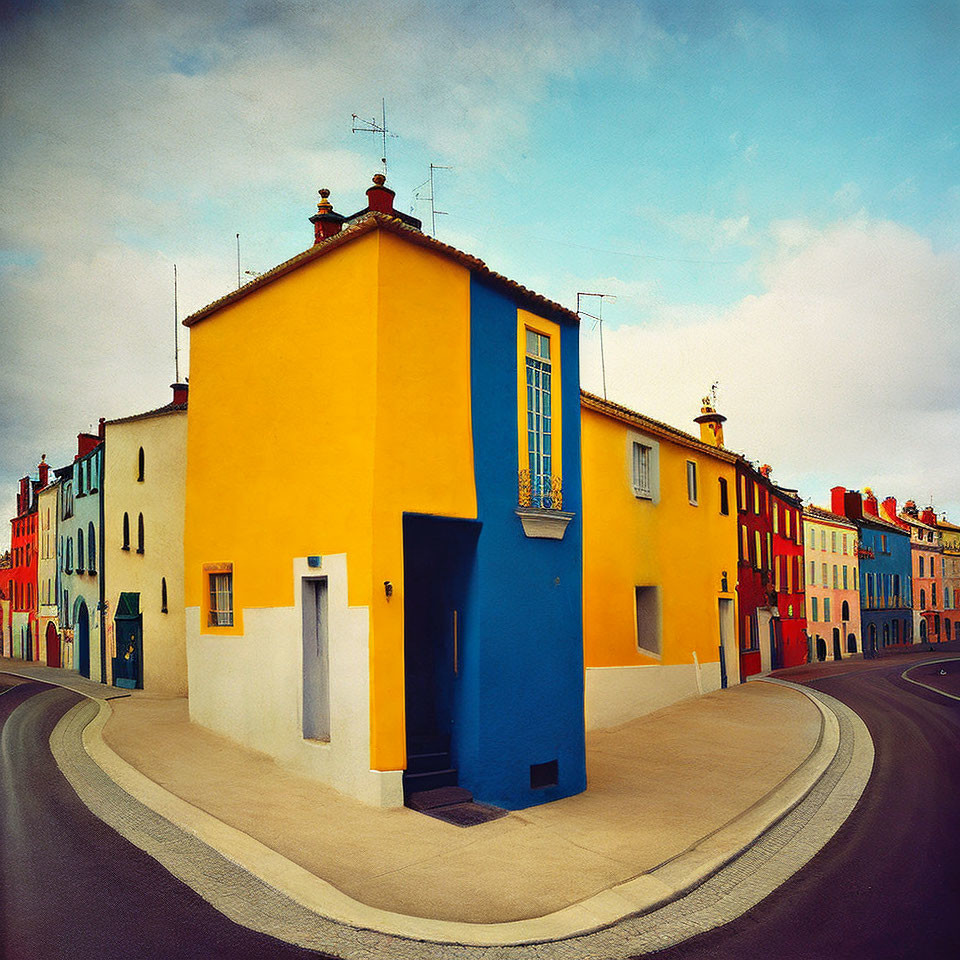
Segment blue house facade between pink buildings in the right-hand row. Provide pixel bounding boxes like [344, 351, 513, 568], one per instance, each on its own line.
[858, 519, 913, 654]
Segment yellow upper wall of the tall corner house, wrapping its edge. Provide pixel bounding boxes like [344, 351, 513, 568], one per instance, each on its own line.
[185, 231, 476, 770]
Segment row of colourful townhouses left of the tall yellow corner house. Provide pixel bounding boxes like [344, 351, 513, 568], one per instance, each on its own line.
[0, 384, 187, 695]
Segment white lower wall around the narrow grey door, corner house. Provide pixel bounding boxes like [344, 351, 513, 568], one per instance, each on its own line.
[186, 554, 403, 807]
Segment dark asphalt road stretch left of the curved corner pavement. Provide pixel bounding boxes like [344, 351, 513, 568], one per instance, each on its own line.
[0, 678, 334, 960]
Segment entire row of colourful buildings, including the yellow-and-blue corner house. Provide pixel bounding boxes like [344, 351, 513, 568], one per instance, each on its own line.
[4, 176, 960, 809]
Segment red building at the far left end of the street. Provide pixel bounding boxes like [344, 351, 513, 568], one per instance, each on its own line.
[6, 457, 50, 660]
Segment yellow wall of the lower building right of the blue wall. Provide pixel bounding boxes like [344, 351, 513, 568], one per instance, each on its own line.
[581, 408, 737, 676]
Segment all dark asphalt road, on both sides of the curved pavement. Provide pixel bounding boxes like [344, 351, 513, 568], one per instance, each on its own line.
[0, 645, 960, 960]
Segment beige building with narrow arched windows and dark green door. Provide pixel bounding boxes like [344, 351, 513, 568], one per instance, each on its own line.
[103, 384, 187, 696]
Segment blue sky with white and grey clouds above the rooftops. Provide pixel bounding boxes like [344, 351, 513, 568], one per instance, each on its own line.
[0, 0, 960, 532]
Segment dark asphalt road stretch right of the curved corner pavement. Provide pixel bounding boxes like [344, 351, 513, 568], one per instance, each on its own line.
[655, 644, 960, 960]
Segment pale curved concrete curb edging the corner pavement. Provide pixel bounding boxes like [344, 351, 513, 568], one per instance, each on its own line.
[39, 678, 859, 948]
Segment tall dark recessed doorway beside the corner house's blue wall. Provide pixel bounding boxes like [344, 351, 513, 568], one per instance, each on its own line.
[403, 514, 480, 768]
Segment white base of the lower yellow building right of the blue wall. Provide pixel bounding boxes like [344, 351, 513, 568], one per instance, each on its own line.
[584, 661, 720, 730]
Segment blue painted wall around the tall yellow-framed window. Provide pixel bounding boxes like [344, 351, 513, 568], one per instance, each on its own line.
[452, 277, 586, 809]
